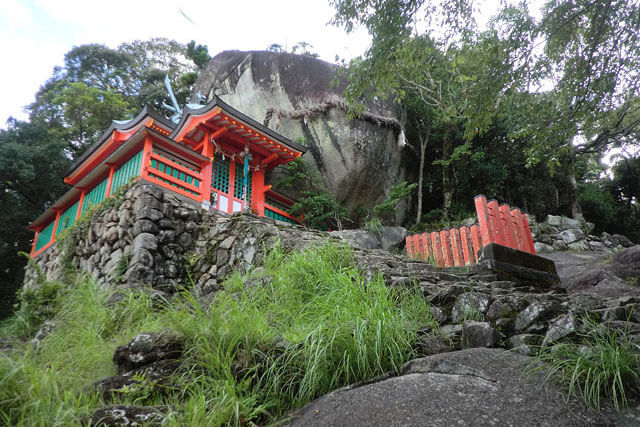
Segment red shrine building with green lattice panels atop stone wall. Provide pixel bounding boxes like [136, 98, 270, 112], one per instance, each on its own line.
[29, 98, 306, 256]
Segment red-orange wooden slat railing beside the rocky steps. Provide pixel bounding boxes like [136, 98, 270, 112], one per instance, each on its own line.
[406, 195, 536, 267]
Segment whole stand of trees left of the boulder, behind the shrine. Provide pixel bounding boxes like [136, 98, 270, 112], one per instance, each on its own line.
[0, 38, 210, 317]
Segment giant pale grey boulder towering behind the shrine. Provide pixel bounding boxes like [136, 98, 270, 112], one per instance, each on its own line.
[194, 51, 405, 223]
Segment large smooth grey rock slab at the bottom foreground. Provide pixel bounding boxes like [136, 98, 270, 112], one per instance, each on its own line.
[291, 348, 608, 426]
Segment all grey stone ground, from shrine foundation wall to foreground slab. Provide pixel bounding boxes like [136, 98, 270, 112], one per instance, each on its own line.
[22, 184, 640, 425]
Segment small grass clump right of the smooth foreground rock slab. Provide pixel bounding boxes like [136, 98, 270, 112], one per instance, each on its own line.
[532, 318, 640, 409]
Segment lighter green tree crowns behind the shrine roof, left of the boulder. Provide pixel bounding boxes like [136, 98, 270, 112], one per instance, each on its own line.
[29, 38, 209, 158]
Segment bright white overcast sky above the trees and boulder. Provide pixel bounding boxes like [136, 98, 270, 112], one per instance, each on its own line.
[0, 0, 368, 128]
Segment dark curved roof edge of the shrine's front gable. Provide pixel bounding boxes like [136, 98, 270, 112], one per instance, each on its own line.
[169, 96, 307, 154]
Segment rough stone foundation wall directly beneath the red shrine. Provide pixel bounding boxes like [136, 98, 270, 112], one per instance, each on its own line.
[24, 181, 328, 292]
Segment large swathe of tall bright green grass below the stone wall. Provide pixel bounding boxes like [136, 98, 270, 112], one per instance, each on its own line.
[0, 244, 437, 425]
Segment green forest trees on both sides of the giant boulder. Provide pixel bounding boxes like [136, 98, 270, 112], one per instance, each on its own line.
[0, 0, 640, 318]
